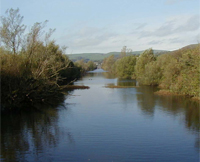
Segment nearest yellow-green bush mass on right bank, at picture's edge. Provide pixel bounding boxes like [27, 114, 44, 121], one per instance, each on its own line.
[161, 46, 200, 97]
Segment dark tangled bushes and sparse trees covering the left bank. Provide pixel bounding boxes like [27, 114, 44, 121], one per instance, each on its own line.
[0, 9, 93, 110]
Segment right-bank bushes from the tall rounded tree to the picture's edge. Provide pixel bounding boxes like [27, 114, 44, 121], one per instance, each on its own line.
[136, 44, 200, 97]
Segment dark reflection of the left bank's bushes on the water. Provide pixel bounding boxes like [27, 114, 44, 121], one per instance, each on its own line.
[1, 93, 74, 162]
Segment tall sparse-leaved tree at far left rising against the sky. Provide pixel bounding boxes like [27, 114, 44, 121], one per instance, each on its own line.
[0, 8, 26, 54]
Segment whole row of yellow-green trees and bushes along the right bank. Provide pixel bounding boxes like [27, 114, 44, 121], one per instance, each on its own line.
[102, 44, 200, 99]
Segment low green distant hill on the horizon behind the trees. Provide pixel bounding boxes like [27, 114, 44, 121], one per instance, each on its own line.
[67, 50, 169, 62]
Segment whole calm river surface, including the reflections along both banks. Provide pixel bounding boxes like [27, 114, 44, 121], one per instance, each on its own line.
[1, 70, 199, 162]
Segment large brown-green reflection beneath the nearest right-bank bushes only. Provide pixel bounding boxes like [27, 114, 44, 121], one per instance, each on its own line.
[136, 86, 200, 131]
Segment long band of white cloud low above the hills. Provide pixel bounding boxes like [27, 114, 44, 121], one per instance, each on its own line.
[58, 15, 200, 53]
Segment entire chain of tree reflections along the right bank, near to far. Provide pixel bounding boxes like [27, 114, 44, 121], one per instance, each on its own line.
[103, 73, 200, 133]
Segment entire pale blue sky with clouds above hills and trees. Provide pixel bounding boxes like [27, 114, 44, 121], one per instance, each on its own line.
[0, 0, 200, 54]
